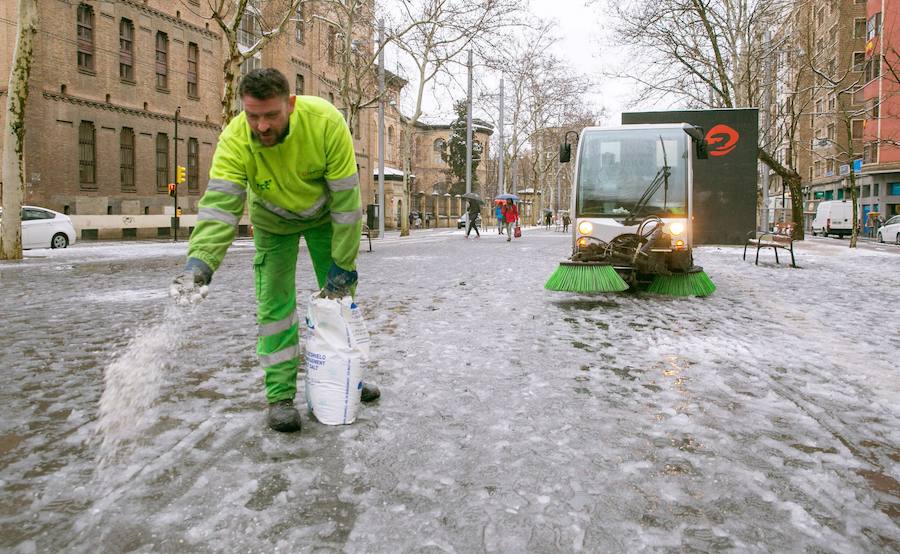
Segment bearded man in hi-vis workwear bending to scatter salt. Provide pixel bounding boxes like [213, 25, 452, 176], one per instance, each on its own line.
[170, 69, 381, 432]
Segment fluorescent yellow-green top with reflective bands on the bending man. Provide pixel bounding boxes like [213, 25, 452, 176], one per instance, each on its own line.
[188, 96, 362, 271]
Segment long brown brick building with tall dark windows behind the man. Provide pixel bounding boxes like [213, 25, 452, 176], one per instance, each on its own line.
[0, 0, 486, 238]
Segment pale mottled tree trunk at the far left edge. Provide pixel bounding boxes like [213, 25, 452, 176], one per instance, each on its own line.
[0, 0, 38, 260]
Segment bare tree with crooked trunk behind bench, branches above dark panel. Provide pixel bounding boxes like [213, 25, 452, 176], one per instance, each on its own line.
[600, 0, 805, 234]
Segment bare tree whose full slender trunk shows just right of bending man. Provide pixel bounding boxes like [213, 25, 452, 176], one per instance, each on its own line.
[397, 0, 521, 236]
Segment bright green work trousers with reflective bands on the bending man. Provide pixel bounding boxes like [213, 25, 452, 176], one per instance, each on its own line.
[253, 222, 332, 403]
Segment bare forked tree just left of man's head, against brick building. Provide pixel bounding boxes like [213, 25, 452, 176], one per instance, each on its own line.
[208, 0, 311, 127]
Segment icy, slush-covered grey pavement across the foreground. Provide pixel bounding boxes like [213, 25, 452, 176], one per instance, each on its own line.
[0, 230, 900, 553]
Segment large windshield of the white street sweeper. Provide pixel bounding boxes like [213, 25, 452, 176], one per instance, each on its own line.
[576, 128, 690, 218]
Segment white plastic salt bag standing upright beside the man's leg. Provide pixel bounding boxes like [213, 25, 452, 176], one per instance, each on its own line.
[305, 292, 369, 425]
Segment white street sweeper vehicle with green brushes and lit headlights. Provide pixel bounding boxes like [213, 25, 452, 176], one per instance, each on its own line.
[545, 123, 715, 296]
